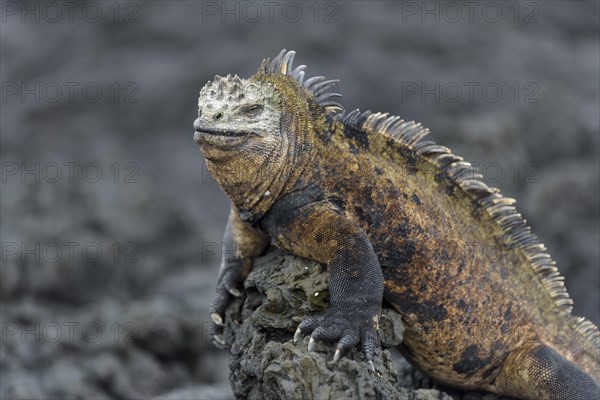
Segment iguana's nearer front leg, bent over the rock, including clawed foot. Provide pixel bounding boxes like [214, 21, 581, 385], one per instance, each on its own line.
[264, 201, 383, 369]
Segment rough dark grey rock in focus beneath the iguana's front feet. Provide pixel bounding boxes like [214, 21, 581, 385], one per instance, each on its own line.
[223, 248, 516, 400]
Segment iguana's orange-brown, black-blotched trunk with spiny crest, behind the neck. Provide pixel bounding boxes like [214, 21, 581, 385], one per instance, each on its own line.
[315, 111, 600, 390]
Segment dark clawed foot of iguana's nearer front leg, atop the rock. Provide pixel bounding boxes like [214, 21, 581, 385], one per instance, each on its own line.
[294, 308, 379, 372]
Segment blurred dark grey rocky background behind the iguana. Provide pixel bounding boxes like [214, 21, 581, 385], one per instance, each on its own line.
[0, 0, 600, 399]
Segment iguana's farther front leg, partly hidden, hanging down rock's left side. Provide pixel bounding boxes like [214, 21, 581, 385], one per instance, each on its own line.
[210, 206, 269, 347]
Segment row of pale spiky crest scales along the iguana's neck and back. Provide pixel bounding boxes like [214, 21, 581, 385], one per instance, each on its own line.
[258, 49, 600, 351]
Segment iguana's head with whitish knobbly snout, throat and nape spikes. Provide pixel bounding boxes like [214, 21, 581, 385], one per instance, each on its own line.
[194, 50, 341, 222]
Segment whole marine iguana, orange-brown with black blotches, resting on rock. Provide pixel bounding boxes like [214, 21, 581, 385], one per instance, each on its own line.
[194, 50, 600, 399]
